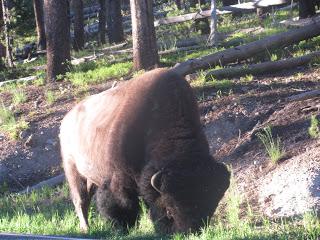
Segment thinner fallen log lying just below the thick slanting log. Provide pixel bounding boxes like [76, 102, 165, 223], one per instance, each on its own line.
[206, 51, 320, 80]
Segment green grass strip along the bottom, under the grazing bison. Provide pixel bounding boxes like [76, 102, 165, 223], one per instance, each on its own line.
[0, 180, 320, 240]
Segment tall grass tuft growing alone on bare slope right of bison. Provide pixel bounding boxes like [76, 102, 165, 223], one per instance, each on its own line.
[257, 126, 285, 164]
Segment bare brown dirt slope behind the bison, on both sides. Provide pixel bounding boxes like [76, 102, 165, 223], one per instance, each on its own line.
[0, 65, 320, 216]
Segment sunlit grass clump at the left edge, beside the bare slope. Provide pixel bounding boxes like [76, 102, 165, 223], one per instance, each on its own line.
[0, 104, 28, 139]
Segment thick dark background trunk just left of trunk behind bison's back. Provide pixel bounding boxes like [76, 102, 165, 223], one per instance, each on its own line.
[107, 0, 124, 43]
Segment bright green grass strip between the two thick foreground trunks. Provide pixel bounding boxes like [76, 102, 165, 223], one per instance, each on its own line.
[67, 62, 132, 86]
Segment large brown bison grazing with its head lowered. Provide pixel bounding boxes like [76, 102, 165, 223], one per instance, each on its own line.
[60, 69, 230, 233]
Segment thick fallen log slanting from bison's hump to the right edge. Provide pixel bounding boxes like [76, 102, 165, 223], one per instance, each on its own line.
[174, 22, 320, 75]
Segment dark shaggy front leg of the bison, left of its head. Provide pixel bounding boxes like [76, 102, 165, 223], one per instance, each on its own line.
[96, 181, 140, 229]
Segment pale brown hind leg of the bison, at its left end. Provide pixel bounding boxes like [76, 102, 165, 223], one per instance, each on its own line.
[64, 164, 95, 233]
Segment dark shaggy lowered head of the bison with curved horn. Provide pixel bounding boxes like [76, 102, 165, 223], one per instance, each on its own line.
[144, 160, 230, 233]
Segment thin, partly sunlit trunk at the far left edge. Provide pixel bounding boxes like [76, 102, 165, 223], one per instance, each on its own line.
[2, 0, 14, 67]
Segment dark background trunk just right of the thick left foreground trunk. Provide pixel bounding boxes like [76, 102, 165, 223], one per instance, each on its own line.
[71, 0, 84, 51]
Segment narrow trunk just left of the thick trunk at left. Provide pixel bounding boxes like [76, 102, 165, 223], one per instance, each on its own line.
[33, 0, 46, 50]
